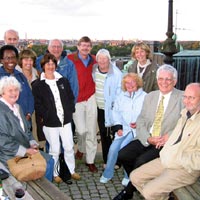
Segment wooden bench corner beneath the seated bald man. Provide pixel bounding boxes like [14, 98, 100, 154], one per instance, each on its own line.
[173, 179, 200, 200]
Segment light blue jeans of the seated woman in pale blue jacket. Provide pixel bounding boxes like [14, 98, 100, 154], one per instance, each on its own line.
[103, 132, 134, 178]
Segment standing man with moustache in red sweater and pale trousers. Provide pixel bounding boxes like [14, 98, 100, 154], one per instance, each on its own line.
[68, 36, 98, 172]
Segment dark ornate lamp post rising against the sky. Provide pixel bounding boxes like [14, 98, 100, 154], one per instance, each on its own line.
[161, 0, 178, 65]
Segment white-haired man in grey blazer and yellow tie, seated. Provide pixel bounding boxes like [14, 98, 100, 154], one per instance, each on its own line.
[114, 64, 183, 200]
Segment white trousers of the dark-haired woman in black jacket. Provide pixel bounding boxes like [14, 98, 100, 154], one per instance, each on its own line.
[43, 123, 75, 176]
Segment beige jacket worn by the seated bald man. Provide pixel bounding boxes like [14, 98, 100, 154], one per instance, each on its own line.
[160, 109, 200, 173]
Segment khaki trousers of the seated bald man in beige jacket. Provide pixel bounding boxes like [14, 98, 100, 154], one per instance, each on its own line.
[130, 158, 200, 200]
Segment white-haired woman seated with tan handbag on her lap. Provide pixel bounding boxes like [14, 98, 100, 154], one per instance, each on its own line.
[0, 76, 54, 181]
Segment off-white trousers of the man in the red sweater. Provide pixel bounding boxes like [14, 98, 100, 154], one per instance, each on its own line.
[73, 95, 97, 164]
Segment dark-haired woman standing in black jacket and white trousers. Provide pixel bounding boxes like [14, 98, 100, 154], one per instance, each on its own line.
[32, 53, 81, 183]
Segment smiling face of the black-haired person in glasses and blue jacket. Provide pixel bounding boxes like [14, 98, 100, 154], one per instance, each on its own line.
[1, 50, 17, 74]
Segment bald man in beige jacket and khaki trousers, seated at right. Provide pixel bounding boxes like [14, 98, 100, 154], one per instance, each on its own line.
[130, 83, 200, 200]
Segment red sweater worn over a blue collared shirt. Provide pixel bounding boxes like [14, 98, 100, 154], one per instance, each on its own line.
[67, 52, 96, 102]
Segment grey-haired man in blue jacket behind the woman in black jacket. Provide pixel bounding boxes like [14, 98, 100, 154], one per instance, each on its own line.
[36, 39, 78, 102]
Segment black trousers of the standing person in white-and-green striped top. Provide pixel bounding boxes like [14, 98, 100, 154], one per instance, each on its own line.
[97, 108, 112, 164]
